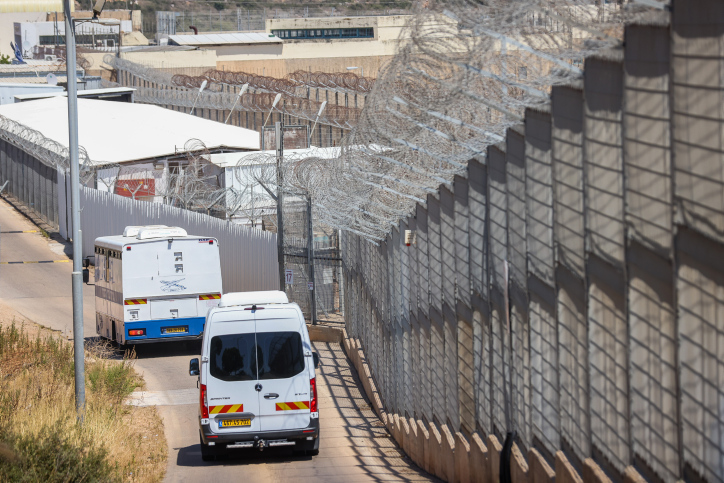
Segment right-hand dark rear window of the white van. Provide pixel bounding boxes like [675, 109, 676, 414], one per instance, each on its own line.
[256, 332, 304, 379]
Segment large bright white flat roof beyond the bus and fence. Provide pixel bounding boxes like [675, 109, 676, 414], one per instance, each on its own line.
[0, 97, 259, 164]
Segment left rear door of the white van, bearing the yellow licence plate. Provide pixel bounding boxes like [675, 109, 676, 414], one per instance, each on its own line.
[206, 312, 261, 434]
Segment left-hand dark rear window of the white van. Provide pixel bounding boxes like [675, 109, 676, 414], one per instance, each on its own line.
[209, 334, 256, 381]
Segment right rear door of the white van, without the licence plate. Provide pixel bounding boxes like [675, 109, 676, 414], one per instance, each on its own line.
[256, 307, 312, 431]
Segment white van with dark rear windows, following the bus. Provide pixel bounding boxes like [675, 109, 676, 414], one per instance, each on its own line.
[189, 291, 319, 461]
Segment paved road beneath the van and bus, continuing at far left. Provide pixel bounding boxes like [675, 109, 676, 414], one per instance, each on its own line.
[0, 200, 434, 483]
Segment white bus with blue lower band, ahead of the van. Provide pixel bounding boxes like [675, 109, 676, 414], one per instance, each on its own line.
[95, 225, 222, 344]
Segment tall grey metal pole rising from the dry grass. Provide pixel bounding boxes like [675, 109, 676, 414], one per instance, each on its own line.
[63, 0, 85, 423]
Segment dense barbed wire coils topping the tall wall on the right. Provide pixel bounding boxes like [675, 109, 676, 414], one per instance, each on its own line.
[268, 0, 656, 241]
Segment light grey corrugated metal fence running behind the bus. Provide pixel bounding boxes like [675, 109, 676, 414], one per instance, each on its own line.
[59, 170, 279, 292]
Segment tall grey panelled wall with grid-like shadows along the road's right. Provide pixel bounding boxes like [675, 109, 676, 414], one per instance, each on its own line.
[342, 9, 724, 483]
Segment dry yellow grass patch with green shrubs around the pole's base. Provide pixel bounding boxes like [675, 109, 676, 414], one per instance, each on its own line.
[0, 323, 166, 482]
